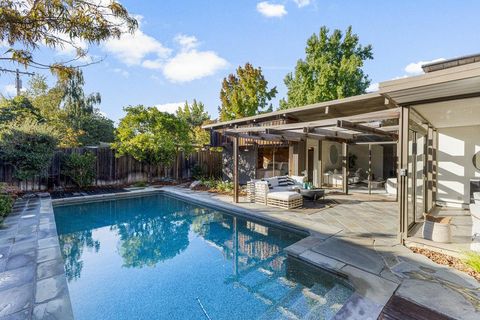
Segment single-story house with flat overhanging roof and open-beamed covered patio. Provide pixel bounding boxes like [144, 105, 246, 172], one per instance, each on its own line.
[204, 55, 480, 239]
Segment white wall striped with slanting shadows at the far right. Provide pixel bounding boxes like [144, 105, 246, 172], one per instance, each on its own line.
[437, 125, 480, 207]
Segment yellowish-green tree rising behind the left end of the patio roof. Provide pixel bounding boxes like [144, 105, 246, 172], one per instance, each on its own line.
[219, 63, 277, 121]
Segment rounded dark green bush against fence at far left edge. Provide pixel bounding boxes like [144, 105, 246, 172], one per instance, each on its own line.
[0, 120, 57, 180]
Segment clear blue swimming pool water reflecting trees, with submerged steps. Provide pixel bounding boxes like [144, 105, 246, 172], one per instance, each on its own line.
[55, 194, 352, 320]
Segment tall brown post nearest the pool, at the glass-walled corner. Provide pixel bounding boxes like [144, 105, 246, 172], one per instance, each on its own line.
[397, 107, 409, 243]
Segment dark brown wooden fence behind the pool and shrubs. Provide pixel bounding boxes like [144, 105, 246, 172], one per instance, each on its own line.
[0, 147, 222, 190]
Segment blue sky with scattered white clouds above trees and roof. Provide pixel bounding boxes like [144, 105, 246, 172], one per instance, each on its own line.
[0, 0, 480, 120]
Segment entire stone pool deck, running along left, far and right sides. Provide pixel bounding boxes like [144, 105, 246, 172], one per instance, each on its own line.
[0, 187, 480, 320]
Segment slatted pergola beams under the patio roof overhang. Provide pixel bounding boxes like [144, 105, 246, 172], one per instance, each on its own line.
[219, 108, 400, 143]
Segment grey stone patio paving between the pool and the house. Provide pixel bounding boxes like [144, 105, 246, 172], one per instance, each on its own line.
[163, 187, 480, 319]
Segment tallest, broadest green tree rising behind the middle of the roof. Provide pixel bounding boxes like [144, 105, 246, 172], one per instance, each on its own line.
[280, 26, 373, 109]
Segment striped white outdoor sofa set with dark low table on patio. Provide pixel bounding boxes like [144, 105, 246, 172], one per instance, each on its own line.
[247, 176, 325, 209]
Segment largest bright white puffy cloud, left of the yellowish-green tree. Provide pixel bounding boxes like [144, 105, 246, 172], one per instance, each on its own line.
[163, 49, 228, 82]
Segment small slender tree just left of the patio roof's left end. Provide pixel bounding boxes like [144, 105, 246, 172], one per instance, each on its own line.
[177, 99, 210, 146]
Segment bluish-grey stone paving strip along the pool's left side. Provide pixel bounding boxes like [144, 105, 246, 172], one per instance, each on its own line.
[0, 194, 73, 320]
